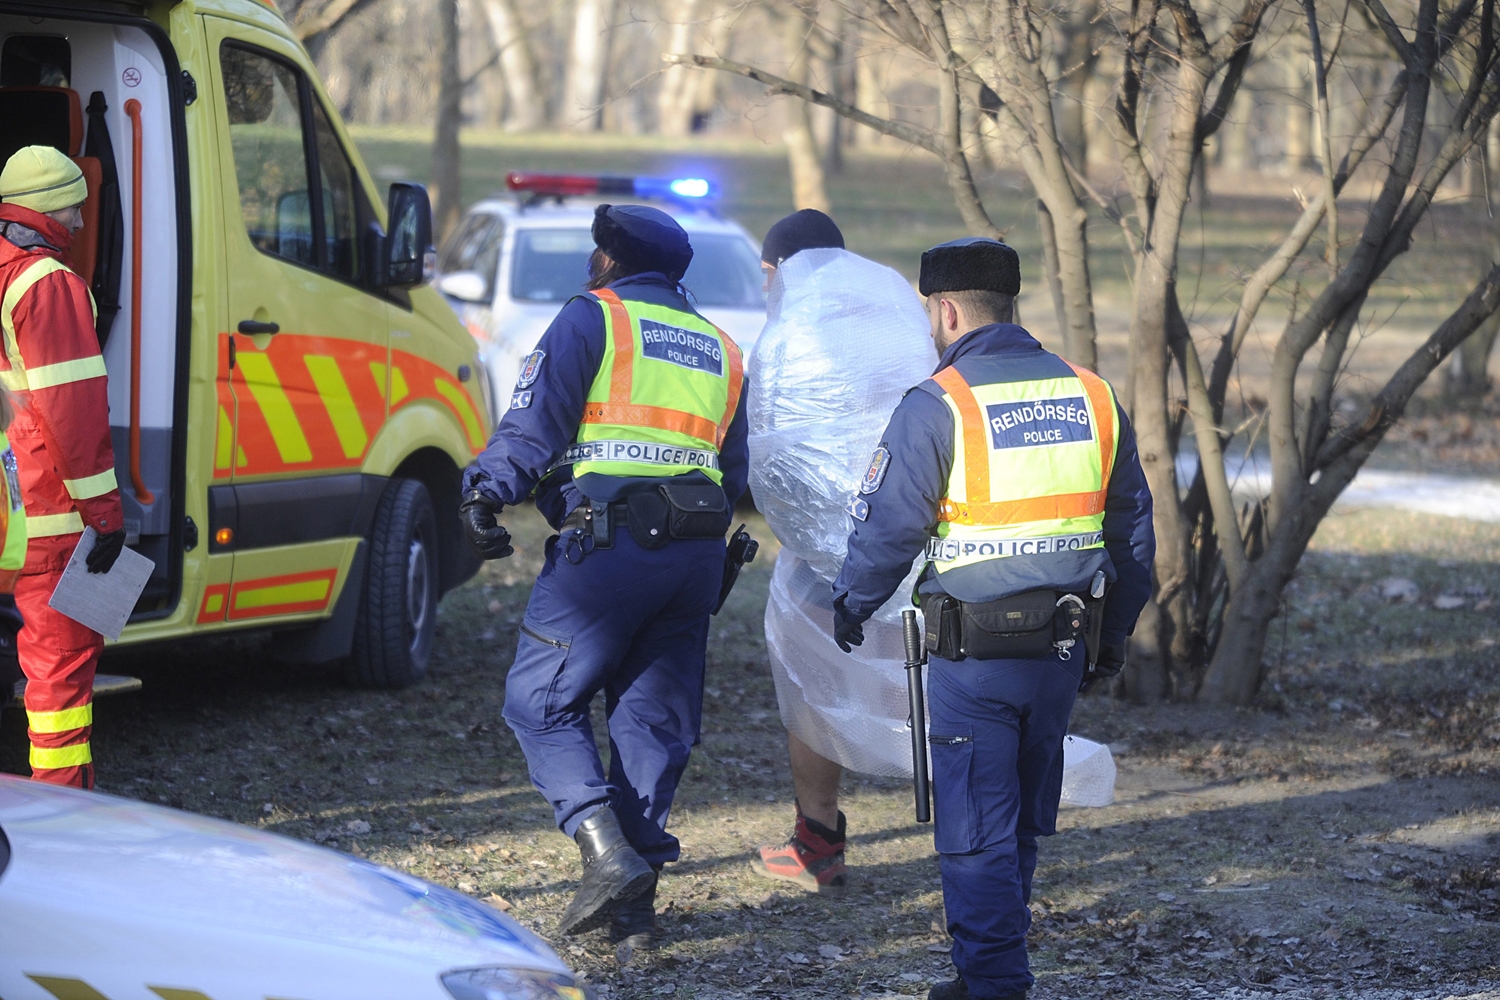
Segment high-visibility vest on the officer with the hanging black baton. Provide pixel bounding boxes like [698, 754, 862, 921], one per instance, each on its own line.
[927, 364, 1119, 580]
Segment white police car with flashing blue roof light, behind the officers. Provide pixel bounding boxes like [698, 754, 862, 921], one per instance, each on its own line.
[438, 172, 765, 413]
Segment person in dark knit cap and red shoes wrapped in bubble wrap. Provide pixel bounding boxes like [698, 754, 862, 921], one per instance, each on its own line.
[747, 208, 938, 892]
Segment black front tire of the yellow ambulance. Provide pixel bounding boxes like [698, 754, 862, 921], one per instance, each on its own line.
[345, 478, 440, 688]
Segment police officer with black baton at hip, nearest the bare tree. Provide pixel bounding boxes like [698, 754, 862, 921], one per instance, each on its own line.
[834, 238, 1155, 1000]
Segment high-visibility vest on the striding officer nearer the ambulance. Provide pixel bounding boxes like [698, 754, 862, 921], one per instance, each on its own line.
[563, 288, 744, 483]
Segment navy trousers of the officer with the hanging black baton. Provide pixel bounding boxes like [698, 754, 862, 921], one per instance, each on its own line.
[927, 645, 1085, 1000]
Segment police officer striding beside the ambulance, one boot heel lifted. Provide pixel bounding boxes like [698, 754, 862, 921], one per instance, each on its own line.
[462, 205, 749, 948]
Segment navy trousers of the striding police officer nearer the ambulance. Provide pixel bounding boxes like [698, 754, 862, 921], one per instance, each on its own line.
[504, 525, 725, 865]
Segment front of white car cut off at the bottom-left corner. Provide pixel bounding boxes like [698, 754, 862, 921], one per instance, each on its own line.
[0, 775, 593, 1000]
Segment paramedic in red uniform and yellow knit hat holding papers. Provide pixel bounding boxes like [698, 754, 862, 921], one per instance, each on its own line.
[0, 145, 125, 789]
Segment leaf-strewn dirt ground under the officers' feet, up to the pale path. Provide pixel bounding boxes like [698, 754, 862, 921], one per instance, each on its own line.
[0, 497, 1500, 1000]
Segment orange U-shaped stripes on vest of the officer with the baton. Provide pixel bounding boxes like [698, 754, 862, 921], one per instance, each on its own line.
[933, 363, 1115, 525]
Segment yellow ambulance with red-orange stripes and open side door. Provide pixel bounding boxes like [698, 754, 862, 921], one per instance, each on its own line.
[0, 0, 492, 687]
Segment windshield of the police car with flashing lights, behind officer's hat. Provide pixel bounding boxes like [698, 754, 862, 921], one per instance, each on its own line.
[510, 229, 765, 309]
